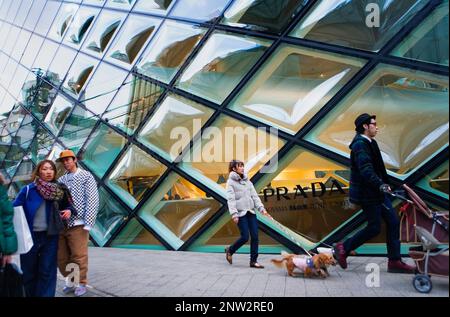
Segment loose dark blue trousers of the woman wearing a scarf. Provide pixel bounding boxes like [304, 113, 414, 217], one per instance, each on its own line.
[20, 232, 58, 297]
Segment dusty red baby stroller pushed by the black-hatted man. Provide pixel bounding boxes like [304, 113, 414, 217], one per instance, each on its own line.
[392, 185, 449, 293]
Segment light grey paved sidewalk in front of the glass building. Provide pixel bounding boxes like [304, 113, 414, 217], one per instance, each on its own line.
[57, 248, 449, 297]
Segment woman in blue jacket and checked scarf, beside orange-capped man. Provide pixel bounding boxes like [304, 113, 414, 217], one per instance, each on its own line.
[13, 160, 73, 297]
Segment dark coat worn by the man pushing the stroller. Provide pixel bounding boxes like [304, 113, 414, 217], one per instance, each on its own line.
[350, 134, 389, 205]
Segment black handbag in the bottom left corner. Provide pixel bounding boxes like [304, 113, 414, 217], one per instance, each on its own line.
[0, 263, 25, 297]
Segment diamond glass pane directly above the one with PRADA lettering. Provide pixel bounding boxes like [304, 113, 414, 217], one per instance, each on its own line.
[231, 45, 363, 134]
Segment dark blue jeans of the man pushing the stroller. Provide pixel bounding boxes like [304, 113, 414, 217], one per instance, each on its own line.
[344, 196, 400, 260]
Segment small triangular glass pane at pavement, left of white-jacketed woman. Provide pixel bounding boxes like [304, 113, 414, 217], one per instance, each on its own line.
[111, 218, 166, 250]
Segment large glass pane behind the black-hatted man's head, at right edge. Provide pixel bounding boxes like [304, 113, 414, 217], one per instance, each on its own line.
[307, 65, 448, 177]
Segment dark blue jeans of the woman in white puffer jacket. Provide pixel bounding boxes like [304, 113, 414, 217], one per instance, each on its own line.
[229, 212, 258, 262]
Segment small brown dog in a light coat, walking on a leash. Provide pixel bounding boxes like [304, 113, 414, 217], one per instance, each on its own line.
[271, 252, 336, 278]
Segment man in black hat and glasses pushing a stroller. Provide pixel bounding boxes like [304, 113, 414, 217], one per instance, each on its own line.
[334, 113, 415, 273]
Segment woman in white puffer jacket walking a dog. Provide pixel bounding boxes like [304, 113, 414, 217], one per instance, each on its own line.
[225, 160, 270, 269]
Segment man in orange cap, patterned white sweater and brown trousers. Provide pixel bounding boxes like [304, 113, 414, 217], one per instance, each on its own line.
[57, 150, 99, 296]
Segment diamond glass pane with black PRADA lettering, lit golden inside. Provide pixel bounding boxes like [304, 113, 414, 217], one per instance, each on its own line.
[256, 147, 358, 242]
